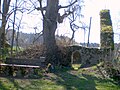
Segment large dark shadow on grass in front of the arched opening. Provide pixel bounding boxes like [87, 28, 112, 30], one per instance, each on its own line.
[55, 67, 119, 90]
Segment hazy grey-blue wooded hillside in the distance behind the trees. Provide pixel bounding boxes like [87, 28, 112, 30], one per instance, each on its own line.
[6, 30, 120, 48]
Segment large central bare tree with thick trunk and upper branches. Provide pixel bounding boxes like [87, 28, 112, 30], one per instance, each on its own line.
[36, 0, 82, 65]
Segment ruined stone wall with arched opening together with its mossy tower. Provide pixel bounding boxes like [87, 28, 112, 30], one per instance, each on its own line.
[68, 9, 114, 67]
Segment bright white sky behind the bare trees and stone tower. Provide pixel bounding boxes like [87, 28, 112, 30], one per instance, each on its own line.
[1, 0, 120, 43]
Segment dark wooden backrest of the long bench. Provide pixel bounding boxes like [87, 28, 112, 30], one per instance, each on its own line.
[5, 57, 45, 66]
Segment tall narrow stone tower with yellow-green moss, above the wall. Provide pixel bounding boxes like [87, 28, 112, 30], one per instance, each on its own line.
[100, 9, 114, 50]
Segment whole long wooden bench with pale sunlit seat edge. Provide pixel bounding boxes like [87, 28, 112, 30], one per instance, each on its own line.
[0, 57, 45, 76]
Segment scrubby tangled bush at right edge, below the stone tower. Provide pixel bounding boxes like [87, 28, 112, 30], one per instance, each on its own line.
[103, 49, 120, 84]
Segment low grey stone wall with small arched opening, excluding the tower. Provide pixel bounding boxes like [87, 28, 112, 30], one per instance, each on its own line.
[69, 45, 110, 67]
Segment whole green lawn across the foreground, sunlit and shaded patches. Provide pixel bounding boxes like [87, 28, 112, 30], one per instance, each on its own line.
[0, 67, 120, 90]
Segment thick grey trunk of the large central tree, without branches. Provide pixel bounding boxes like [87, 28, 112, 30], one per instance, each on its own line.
[43, 0, 59, 65]
